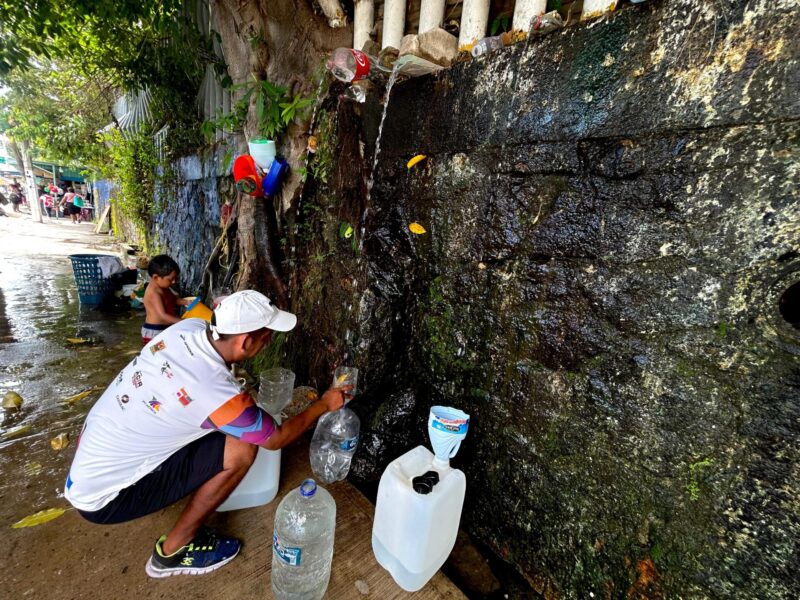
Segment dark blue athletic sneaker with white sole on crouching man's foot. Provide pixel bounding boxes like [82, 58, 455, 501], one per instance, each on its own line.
[144, 528, 242, 577]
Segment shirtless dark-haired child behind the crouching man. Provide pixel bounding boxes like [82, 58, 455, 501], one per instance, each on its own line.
[142, 254, 187, 346]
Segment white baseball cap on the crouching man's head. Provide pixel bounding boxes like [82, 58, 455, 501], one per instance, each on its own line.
[211, 290, 297, 340]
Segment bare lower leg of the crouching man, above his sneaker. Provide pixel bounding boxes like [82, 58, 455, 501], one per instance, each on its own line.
[161, 436, 253, 554]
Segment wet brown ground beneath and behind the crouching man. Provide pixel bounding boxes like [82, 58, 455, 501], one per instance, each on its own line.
[0, 215, 464, 600]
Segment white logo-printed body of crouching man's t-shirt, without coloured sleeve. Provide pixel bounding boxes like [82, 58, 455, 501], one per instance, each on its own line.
[64, 319, 242, 511]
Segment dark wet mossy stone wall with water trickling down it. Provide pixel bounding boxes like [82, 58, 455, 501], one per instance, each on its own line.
[288, 0, 800, 598]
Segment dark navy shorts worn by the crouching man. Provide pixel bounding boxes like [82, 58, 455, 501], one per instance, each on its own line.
[78, 431, 227, 525]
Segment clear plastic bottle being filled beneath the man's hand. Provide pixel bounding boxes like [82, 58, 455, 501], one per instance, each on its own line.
[310, 406, 361, 483]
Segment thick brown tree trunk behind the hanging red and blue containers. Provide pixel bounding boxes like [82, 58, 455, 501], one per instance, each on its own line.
[213, 0, 353, 308]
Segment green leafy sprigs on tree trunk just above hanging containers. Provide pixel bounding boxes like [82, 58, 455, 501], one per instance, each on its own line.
[201, 80, 313, 140]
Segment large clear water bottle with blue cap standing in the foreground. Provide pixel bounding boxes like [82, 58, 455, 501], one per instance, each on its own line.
[272, 479, 336, 600]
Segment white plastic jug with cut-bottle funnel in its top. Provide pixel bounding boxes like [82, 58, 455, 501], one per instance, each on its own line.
[372, 406, 469, 592]
